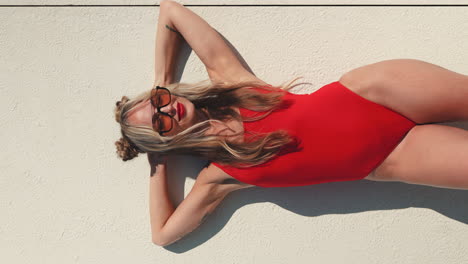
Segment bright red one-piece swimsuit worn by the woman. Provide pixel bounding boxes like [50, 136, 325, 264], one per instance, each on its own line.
[213, 82, 416, 187]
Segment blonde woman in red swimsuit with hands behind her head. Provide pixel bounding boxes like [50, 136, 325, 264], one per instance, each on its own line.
[115, 1, 468, 248]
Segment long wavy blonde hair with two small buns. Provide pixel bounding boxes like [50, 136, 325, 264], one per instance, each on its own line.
[114, 77, 301, 167]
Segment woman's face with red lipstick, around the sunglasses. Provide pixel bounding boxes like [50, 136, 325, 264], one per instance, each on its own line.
[127, 95, 204, 136]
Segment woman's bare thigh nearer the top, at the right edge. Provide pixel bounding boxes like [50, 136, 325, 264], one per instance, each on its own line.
[340, 59, 468, 124]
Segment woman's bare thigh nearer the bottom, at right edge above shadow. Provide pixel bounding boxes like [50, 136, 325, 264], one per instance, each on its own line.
[367, 124, 468, 189]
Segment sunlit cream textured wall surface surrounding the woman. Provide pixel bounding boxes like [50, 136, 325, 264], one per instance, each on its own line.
[0, 0, 468, 263]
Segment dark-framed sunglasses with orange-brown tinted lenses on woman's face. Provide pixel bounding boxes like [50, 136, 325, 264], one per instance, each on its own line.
[150, 86, 174, 136]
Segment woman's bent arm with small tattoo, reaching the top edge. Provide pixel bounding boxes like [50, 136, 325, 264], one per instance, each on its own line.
[156, 0, 264, 83]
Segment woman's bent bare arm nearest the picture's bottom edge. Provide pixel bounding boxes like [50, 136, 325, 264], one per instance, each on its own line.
[148, 153, 245, 246]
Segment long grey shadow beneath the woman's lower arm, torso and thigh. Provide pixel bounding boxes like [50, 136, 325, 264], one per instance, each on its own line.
[164, 162, 468, 253]
